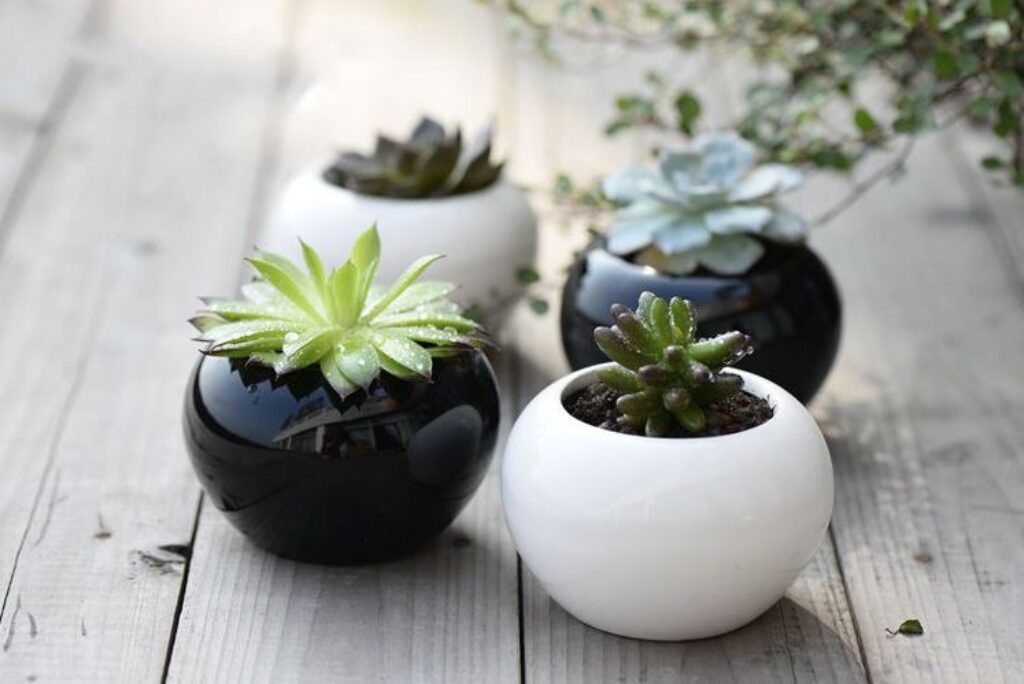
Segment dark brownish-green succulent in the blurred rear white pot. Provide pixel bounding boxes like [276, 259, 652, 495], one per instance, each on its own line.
[324, 118, 504, 199]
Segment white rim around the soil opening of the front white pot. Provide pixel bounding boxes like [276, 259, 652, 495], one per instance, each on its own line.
[552, 361, 782, 447]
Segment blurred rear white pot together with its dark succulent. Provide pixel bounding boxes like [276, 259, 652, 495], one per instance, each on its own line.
[261, 118, 537, 324]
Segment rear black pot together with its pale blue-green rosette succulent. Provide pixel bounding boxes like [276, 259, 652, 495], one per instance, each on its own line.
[561, 133, 841, 401]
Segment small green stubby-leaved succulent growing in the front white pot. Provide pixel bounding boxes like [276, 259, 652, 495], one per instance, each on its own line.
[594, 292, 753, 437]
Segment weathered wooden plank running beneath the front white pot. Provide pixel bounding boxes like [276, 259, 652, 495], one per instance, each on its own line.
[503, 38, 864, 682]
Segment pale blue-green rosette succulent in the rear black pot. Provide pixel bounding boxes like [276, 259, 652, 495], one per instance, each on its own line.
[603, 132, 807, 275]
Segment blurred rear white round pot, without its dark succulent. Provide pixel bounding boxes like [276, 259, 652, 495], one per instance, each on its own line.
[258, 166, 537, 325]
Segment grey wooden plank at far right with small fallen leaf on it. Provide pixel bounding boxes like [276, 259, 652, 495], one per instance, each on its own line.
[806, 129, 1024, 682]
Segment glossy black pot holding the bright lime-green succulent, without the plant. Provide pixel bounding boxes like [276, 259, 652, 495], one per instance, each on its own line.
[184, 350, 499, 563]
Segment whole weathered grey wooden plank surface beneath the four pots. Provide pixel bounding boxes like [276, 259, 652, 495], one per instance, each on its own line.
[0, 0, 1024, 683]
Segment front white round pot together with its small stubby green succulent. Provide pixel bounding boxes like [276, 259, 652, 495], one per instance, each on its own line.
[502, 292, 833, 640]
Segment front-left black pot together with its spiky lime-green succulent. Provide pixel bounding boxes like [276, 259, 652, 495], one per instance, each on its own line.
[184, 227, 499, 563]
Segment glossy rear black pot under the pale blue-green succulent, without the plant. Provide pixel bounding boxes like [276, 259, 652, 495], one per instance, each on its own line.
[561, 238, 841, 403]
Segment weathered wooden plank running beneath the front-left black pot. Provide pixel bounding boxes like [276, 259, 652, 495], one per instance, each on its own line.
[169, 0, 519, 682]
